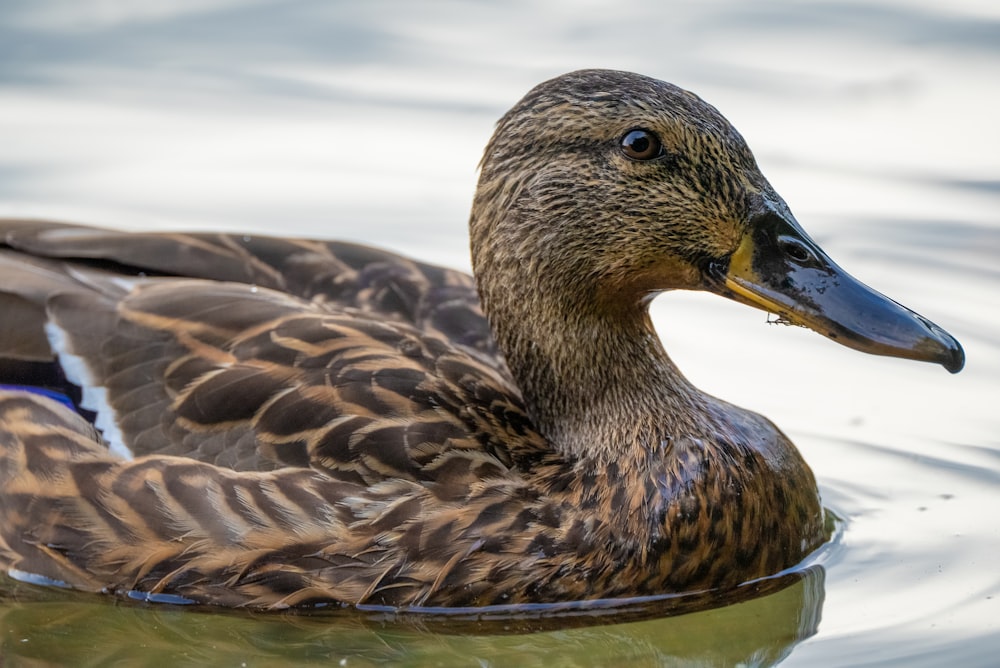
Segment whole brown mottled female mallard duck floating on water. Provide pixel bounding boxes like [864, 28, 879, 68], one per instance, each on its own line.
[0, 71, 963, 608]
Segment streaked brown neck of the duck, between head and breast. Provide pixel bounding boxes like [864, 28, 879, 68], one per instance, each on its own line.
[480, 268, 707, 464]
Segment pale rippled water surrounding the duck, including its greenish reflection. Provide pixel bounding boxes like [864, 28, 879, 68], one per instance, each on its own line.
[0, 0, 1000, 666]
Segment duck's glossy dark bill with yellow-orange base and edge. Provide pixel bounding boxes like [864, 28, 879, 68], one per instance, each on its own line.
[710, 213, 965, 373]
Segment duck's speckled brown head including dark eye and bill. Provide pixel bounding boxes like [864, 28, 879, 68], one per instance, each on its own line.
[471, 70, 964, 372]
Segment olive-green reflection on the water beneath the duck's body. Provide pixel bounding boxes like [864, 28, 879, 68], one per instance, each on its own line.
[0, 566, 824, 666]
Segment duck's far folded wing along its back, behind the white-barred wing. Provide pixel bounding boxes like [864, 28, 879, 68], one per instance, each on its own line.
[0, 219, 506, 370]
